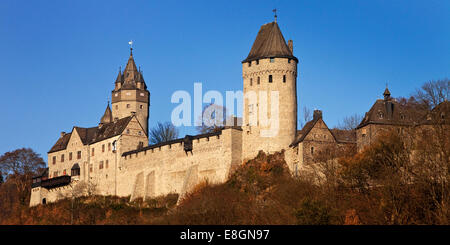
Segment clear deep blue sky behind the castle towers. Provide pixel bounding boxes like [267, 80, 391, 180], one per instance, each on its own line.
[0, 0, 450, 162]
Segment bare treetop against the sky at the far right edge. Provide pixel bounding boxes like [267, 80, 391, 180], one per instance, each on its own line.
[413, 78, 450, 109]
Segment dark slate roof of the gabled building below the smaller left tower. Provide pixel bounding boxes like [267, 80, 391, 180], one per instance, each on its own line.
[48, 116, 133, 153]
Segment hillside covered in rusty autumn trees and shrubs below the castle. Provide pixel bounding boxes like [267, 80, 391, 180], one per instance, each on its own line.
[0, 130, 450, 225]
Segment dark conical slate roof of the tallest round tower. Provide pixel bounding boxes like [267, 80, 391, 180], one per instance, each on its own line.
[242, 22, 298, 63]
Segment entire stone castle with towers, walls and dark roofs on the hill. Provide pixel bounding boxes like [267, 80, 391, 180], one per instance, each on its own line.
[30, 20, 448, 206]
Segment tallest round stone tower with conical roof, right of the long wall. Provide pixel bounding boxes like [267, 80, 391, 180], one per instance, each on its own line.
[242, 21, 298, 160]
